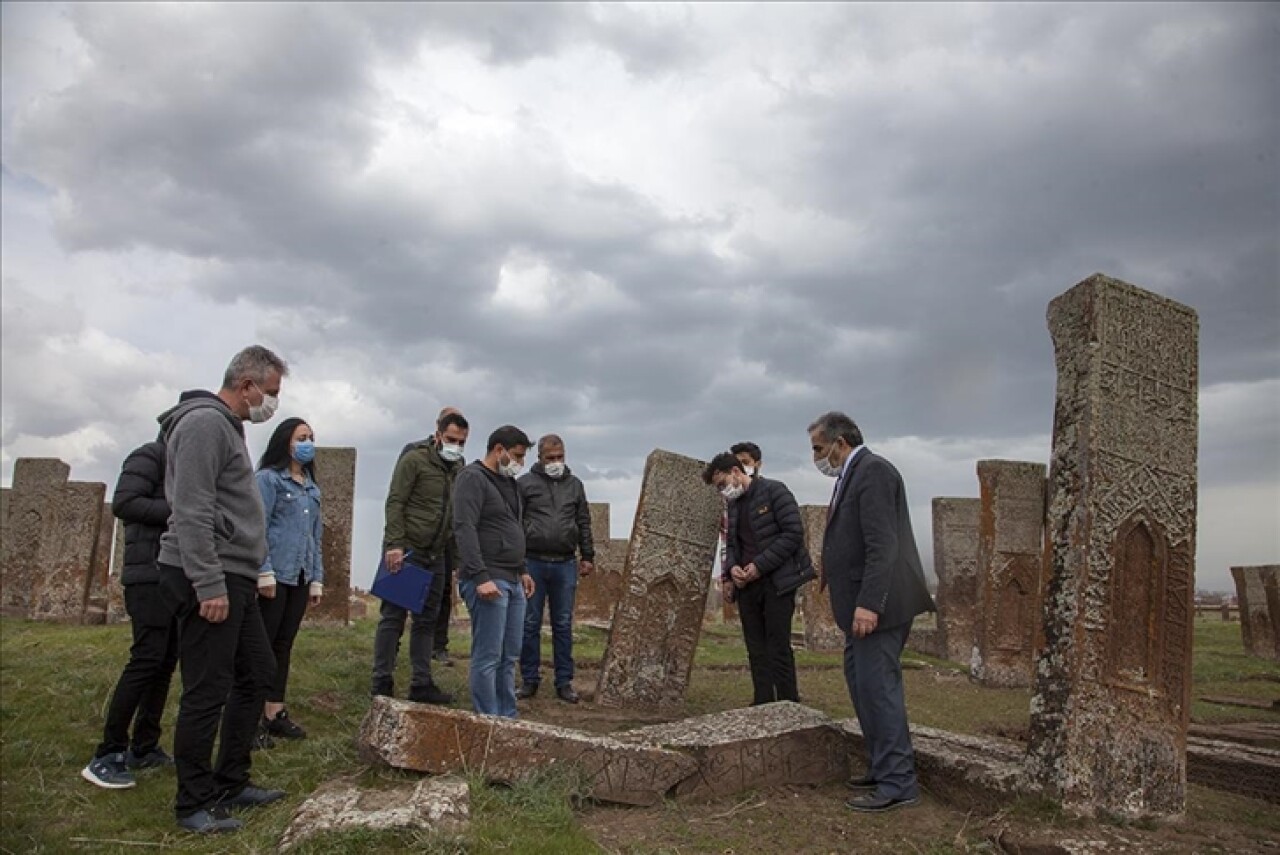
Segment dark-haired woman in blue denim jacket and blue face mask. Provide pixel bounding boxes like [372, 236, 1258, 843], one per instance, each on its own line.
[257, 419, 324, 747]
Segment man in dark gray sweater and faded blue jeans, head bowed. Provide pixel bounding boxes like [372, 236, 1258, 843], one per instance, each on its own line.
[453, 425, 534, 718]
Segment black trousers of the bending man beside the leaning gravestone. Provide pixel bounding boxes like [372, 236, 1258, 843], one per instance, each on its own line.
[737, 579, 800, 704]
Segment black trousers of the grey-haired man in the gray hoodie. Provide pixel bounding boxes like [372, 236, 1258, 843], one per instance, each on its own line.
[160, 564, 275, 817]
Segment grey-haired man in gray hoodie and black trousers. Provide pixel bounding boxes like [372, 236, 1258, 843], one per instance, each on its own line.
[157, 344, 288, 833]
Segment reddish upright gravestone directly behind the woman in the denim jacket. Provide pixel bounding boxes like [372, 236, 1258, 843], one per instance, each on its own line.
[307, 447, 356, 625]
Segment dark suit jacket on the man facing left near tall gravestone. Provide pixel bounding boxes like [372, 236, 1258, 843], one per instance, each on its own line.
[822, 447, 936, 634]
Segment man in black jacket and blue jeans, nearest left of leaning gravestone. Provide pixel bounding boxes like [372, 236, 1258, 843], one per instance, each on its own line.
[516, 434, 595, 704]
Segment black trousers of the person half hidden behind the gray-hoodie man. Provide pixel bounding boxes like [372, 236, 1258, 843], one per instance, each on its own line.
[93, 582, 178, 756]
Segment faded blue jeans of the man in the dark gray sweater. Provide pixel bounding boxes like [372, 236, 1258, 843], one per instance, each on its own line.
[458, 579, 525, 718]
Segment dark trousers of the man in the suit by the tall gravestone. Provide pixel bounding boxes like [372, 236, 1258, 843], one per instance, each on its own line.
[845, 621, 920, 799]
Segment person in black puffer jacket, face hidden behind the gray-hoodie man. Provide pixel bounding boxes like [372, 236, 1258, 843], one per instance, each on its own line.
[81, 440, 178, 790]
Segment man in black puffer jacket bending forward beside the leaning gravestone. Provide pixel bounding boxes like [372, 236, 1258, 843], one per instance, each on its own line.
[703, 452, 814, 705]
